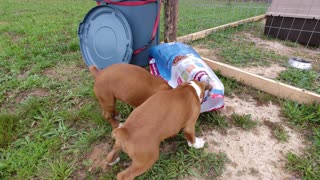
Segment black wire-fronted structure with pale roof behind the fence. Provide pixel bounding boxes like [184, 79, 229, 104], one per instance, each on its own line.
[264, 0, 320, 46]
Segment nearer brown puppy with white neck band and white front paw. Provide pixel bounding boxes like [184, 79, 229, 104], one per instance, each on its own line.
[107, 81, 212, 180]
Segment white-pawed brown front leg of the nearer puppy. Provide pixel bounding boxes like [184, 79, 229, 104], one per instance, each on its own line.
[183, 123, 205, 149]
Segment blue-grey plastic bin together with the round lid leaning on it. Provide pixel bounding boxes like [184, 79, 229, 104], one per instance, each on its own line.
[78, 0, 161, 69]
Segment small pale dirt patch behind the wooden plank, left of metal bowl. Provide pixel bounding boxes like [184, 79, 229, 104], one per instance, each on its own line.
[242, 64, 287, 79]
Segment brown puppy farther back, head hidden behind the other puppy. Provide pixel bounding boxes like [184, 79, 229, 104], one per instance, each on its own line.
[90, 64, 171, 128]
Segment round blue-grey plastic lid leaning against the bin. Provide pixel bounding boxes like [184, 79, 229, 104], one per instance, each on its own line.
[78, 5, 132, 69]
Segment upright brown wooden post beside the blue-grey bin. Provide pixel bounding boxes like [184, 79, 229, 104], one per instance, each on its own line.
[164, 0, 179, 43]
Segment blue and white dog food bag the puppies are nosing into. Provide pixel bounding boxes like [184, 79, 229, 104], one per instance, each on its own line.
[149, 42, 224, 112]
